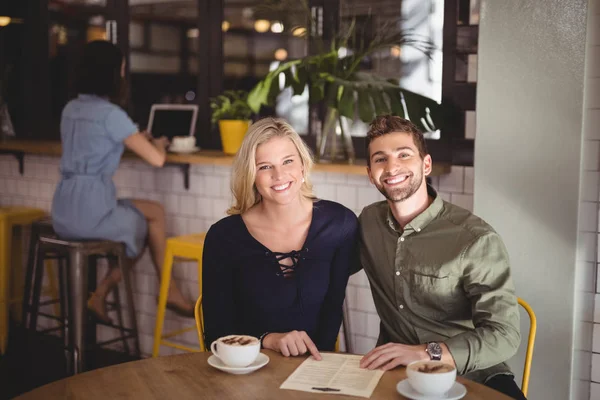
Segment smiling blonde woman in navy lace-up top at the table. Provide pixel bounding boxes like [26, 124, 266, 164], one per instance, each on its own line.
[202, 118, 358, 359]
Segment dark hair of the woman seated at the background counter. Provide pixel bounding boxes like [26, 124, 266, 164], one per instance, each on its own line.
[75, 40, 127, 106]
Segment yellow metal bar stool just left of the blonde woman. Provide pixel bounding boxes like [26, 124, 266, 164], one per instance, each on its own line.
[152, 233, 206, 357]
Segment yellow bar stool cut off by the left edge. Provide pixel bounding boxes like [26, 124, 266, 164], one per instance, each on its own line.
[0, 206, 46, 354]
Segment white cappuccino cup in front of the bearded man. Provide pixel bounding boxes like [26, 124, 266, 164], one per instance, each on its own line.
[406, 361, 456, 396]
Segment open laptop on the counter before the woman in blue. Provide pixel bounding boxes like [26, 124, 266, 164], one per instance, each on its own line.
[148, 104, 198, 141]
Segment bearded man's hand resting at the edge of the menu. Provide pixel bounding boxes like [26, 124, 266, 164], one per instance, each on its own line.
[360, 343, 430, 371]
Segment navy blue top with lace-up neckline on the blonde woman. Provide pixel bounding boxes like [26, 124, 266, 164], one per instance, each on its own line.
[202, 200, 358, 351]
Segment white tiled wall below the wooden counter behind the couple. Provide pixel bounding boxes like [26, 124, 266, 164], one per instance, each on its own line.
[0, 156, 473, 355]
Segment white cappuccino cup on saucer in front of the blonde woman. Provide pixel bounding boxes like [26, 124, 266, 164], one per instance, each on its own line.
[210, 335, 260, 367]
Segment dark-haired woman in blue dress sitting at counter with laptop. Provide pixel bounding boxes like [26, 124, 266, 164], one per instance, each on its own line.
[52, 41, 193, 322]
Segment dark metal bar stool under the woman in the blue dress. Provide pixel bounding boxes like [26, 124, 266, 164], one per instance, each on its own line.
[24, 235, 140, 374]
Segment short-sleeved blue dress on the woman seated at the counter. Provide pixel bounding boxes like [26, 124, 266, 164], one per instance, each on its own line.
[52, 95, 148, 258]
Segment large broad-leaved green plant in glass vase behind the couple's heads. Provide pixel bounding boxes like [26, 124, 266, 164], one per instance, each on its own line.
[248, 1, 443, 163]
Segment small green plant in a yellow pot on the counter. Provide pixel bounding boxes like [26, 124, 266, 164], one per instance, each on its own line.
[210, 90, 253, 155]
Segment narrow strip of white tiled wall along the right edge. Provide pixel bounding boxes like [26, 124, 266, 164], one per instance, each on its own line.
[571, 0, 600, 400]
